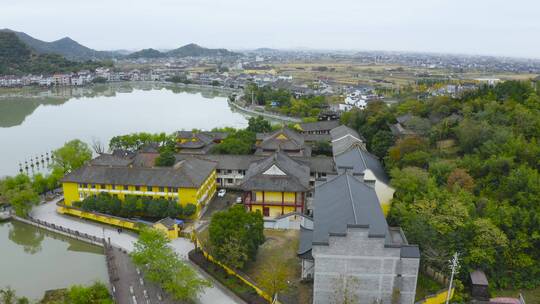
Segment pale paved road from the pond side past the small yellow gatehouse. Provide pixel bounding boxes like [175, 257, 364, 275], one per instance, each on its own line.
[31, 200, 242, 304]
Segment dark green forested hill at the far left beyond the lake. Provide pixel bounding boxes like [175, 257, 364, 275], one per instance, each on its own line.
[0, 31, 109, 75]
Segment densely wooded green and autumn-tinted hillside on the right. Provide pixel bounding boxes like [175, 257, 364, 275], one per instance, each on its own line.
[343, 81, 540, 289]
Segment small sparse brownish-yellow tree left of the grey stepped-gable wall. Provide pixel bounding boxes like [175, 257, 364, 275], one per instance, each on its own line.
[257, 256, 291, 296]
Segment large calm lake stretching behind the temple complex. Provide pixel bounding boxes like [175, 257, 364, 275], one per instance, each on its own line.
[0, 83, 247, 176]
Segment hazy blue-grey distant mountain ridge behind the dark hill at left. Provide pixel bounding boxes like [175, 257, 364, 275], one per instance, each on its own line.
[0, 29, 115, 61]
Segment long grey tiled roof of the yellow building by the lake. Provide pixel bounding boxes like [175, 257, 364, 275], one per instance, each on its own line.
[63, 158, 216, 188]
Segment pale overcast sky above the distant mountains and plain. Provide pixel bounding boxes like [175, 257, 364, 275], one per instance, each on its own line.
[0, 0, 540, 58]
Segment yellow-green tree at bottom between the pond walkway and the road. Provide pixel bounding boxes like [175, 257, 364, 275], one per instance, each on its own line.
[131, 228, 211, 300]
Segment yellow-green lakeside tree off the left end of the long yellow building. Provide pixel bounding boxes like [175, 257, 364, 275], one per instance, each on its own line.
[51, 139, 92, 173]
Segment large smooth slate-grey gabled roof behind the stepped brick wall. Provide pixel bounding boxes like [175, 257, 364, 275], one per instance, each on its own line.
[313, 173, 388, 244]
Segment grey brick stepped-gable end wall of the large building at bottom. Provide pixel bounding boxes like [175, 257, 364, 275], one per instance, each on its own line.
[312, 228, 419, 304]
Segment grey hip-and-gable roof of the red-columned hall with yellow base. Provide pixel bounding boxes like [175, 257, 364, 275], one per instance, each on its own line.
[241, 152, 309, 192]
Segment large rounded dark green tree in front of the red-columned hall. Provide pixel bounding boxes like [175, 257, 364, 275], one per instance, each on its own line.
[209, 205, 264, 268]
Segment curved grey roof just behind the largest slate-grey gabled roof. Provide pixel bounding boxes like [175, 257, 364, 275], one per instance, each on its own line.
[334, 147, 389, 184]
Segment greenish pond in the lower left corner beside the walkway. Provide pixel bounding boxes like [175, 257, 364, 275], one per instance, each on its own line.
[0, 221, 108, 299]
